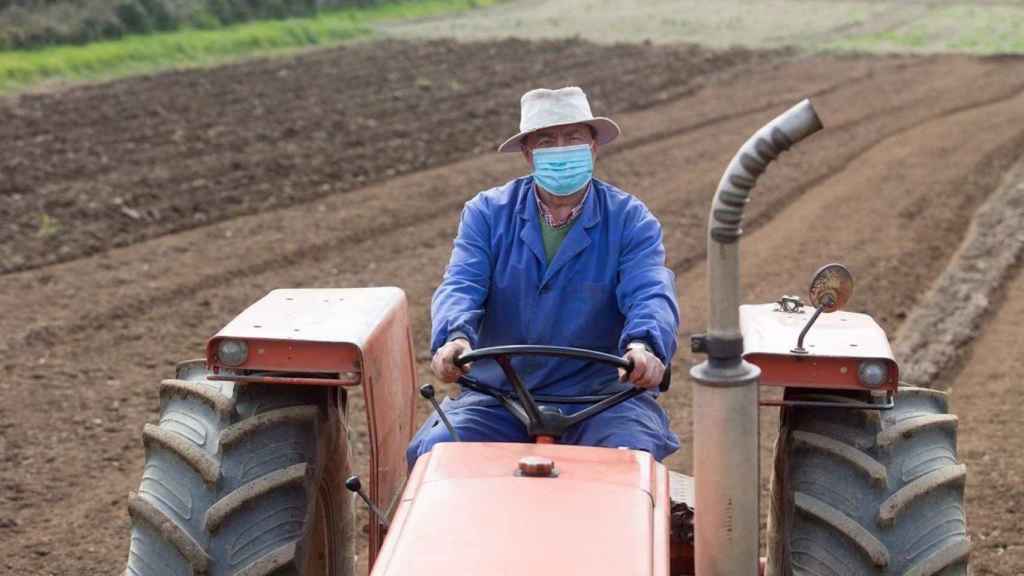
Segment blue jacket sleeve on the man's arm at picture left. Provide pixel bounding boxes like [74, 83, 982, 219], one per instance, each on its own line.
[430, 197, 492, 353]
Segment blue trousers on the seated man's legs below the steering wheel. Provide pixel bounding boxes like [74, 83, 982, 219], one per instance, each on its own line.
[406, 395, 679, 467]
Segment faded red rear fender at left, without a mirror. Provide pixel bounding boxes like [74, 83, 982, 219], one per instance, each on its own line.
[206, 288, 417, 563]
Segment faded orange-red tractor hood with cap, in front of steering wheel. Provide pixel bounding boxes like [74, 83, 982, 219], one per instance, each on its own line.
[373, 443, 669, 576]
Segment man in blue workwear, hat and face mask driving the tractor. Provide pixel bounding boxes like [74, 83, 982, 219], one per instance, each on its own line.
[407, 87, 679, 466]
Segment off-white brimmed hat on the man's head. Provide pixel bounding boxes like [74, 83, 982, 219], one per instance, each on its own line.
[498, 86, 622, 152]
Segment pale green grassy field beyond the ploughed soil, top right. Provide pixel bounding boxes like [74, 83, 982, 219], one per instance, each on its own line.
[379, 0, 1024, 54]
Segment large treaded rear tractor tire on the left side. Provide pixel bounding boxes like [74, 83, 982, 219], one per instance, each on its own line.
[125, 361, 354, 576]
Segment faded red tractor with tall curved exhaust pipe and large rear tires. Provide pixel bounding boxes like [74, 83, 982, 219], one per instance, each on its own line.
[119, 100, 970, 576]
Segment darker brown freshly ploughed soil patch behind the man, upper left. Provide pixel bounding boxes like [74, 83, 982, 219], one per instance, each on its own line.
[0, 40, 762, 273]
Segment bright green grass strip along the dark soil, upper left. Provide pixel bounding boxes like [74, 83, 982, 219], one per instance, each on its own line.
[0, 0, 496, 92]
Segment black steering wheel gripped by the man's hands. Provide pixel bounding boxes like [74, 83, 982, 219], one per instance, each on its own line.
[455, 345, 672, 438]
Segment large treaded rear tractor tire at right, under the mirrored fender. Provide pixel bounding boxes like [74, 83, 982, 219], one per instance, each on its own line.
[766, 387, 971, 576]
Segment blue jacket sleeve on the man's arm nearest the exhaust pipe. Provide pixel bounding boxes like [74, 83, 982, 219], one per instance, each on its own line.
[615, 202, 679, 364]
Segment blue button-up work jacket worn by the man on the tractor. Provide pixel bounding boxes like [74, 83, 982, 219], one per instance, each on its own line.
[431, 176, 679, 408]
